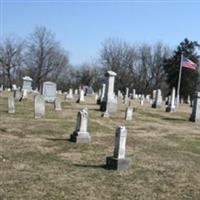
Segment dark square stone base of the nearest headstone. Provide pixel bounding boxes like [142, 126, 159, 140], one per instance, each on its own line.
[106, 157, 130, 170]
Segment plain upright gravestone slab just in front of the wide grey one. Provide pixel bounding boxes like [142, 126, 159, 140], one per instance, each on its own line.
[34, 94, 45, 118]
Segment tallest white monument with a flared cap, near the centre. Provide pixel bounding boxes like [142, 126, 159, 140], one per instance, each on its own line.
[100, 71, 117, 114]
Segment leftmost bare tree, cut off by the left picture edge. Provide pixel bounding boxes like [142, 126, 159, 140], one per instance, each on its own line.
[0, 37, 23, 88]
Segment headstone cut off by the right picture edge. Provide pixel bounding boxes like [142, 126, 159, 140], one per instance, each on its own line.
[190, 92, 200, 123]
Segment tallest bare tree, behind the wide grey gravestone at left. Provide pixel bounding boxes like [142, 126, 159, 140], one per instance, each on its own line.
[25, 27, 69, 88]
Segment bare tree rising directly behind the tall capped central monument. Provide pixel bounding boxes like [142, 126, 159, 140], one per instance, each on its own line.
[100, 39, 137, 91]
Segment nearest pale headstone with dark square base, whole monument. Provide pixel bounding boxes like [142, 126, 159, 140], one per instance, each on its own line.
[106, 126, 130, 170]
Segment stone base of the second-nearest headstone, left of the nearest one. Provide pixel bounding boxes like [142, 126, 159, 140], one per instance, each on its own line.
[70, 132, 91, 144]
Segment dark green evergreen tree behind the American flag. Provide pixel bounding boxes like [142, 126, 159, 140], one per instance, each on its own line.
[164, 38, 199, 99]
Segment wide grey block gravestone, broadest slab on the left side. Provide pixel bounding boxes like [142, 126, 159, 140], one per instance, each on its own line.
[42, 81, 56, 103]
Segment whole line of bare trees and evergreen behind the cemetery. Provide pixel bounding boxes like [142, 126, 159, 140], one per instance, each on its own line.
[0, 27, 199, 98]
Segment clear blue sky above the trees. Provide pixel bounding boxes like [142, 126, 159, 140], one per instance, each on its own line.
[0, 0, 200, 64]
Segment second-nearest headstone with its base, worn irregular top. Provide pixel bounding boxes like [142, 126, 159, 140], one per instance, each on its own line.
[71, 109, 91, 143]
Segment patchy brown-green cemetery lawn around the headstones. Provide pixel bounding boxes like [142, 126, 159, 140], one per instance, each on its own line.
[0, 93, 200, 200]
